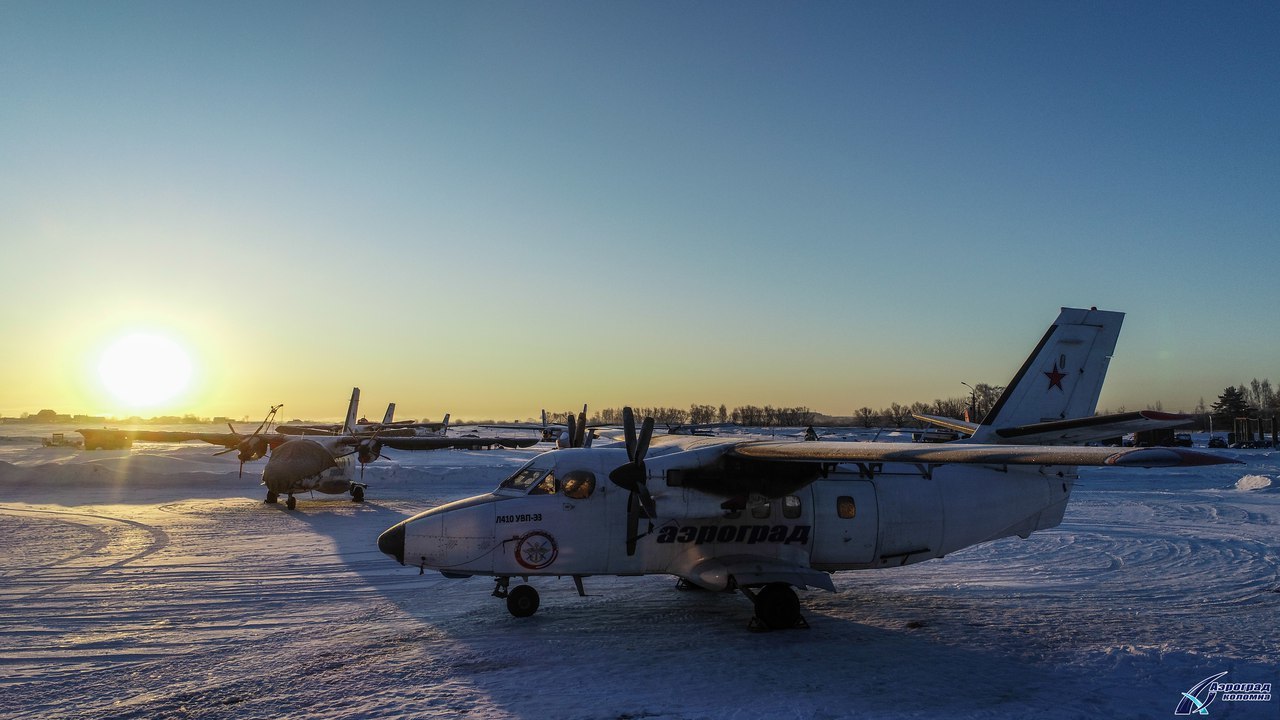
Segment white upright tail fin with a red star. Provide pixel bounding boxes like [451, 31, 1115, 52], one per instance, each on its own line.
[969, 307, 1124, 442]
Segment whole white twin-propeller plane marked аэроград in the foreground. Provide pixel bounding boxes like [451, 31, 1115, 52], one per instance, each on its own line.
[378, 309, 1230, 629]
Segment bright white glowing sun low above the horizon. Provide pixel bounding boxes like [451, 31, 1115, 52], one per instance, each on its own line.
[97, 333, 191, 407]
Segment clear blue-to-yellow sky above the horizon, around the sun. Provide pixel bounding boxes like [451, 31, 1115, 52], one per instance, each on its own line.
[0, 0, 1280, 418]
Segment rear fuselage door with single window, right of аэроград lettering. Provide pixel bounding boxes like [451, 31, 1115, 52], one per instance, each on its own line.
[810, 480, 879, 568]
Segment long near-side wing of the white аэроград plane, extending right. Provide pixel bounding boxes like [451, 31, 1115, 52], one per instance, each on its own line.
[730, 441, 1238, 468]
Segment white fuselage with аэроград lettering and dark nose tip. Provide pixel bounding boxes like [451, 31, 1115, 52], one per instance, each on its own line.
[381, 446, 1074, 589]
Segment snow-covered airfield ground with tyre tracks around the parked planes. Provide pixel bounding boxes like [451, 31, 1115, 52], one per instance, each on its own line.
[0, 425, 1280, 719]
